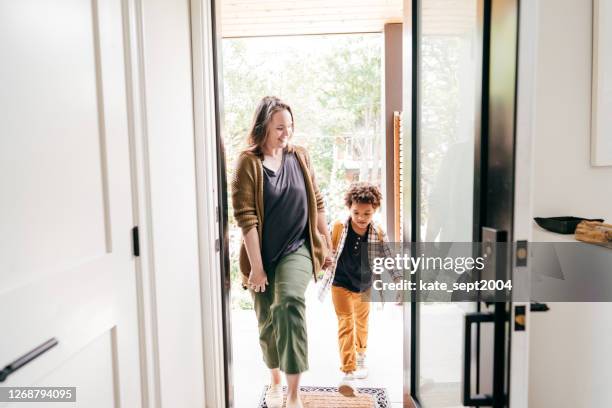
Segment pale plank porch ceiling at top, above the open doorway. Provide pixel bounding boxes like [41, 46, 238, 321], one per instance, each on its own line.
[217, 0, 477, 38]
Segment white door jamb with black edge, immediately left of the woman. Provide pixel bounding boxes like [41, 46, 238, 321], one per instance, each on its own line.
[190, 0, 228, 407]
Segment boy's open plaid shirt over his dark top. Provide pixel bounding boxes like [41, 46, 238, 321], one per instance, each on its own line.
[318, 217, 403, 302]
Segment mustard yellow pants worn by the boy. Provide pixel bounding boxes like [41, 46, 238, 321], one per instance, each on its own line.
[332, 286, 370, 373]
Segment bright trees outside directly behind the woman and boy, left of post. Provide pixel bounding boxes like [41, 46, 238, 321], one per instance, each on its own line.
[222, 34, 383, 308]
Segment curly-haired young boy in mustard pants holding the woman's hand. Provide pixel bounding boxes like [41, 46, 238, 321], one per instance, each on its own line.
[319, 182, 401, 397]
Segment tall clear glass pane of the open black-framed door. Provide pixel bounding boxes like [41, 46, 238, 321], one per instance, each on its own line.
[417, 0, 481, 408]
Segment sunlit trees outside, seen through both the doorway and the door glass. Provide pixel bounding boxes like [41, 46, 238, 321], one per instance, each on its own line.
[222, 34, 466, 309]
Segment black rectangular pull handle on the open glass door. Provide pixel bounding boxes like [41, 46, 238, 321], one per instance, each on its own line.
[463, 312, 494, 407]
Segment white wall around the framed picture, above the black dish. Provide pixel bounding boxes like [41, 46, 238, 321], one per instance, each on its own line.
[534, 0, 612, 222]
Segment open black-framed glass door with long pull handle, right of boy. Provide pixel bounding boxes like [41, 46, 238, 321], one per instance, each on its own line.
[406, 0, 518, 408]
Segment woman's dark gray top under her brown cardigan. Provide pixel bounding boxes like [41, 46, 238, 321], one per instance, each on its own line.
[261, 152, 308, 270]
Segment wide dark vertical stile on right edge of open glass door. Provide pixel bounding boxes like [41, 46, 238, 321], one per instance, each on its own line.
[482, 0, 519, 408]
